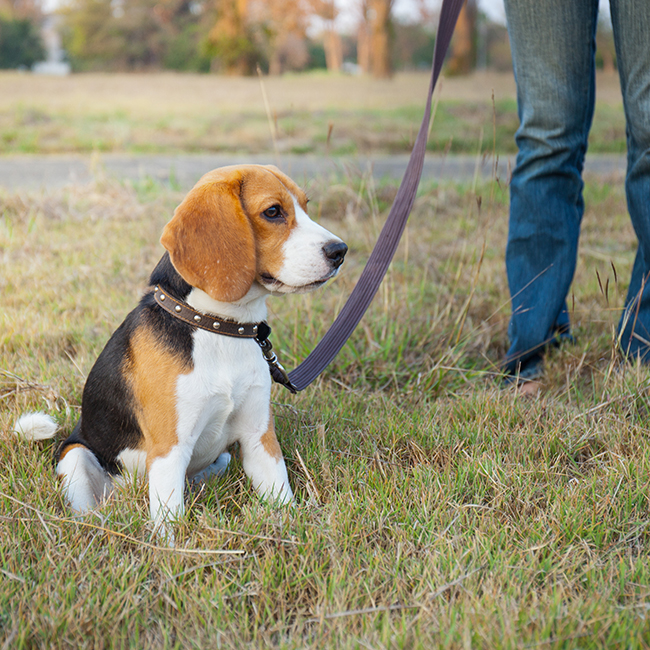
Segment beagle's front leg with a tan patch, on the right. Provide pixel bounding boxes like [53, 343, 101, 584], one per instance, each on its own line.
[236, 402, 293, 505]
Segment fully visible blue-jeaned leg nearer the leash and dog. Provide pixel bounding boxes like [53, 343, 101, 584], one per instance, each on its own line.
[504, 0, 596, 378]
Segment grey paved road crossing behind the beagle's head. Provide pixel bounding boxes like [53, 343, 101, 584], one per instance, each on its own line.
[0, 154, 625, 190]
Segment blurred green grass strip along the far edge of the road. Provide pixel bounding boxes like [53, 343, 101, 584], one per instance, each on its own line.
[0, 100, 625, 155]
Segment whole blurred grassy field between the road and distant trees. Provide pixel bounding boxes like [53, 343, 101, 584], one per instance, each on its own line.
[0, 72, 625, 155]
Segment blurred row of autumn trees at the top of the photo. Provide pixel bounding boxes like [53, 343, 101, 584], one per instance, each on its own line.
[0, 0, 615, 78]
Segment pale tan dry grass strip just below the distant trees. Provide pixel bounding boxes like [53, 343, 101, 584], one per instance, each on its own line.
[0, 72, 516, 117]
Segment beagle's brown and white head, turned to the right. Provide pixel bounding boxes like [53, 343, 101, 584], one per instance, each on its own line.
[160, 165, 347, 302]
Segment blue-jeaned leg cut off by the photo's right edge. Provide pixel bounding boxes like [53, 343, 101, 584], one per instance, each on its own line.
[610, 0, 650, 362]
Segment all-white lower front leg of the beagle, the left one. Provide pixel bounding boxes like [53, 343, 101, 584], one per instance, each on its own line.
[149, 445, 189, 543]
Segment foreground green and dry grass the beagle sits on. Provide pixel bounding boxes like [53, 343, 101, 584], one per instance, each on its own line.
[0, 170, 650, 649]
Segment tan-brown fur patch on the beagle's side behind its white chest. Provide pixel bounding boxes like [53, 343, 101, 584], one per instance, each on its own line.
[123, 326, 192, 468]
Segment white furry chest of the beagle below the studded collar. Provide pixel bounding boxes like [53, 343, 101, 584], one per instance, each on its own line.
[176, 330, 271, 476]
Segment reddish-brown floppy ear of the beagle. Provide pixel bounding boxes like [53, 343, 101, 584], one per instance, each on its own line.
[160, 182, 256, 302]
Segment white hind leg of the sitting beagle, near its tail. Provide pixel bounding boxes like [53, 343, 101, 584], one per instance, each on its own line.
[56, 444, 113, 513]
